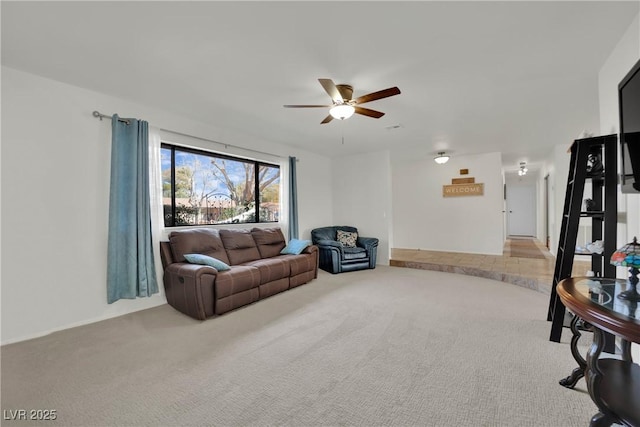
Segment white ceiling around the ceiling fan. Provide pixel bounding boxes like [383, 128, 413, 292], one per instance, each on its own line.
[1, 1, 639, 168]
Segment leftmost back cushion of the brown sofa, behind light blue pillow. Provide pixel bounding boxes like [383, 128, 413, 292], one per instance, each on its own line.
[169, 228, 229, 264]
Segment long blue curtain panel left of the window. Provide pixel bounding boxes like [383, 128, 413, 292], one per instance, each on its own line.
[107, 114, 158, 304]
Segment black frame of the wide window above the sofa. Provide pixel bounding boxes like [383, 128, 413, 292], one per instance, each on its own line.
[160, 141, 282, 228]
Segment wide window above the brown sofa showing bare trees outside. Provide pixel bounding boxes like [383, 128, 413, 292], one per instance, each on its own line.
[161, 144, 280, 227]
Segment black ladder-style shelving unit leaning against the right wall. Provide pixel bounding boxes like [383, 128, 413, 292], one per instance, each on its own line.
[547, 135, 618, 344]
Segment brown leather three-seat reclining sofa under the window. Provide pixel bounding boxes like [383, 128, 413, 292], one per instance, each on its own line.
[160, 228, 318, 320]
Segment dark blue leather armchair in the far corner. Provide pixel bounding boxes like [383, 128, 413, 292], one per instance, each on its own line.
[311, 225, 378, 274]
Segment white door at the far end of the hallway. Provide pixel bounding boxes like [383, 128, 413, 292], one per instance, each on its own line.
[507, 184, 536, 236]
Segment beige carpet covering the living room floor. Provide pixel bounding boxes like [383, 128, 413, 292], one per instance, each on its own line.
[2, 267, 596, 427]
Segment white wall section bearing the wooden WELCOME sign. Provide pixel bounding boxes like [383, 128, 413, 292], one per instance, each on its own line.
[391, 153, 504, 255]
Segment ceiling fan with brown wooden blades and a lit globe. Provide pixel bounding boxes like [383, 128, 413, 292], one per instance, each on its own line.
[283, 79, 400, 124]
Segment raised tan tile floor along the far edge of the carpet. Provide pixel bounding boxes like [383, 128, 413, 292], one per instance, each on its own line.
[389, 239, 591, 294]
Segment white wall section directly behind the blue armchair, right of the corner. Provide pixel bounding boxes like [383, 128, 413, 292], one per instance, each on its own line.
[331, 151, 391, 265]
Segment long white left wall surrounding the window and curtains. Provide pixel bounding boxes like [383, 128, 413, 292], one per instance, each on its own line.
[1, 67, 332, 344]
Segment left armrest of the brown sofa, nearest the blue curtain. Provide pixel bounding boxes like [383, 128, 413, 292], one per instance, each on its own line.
[164, 262, 218, 320]
